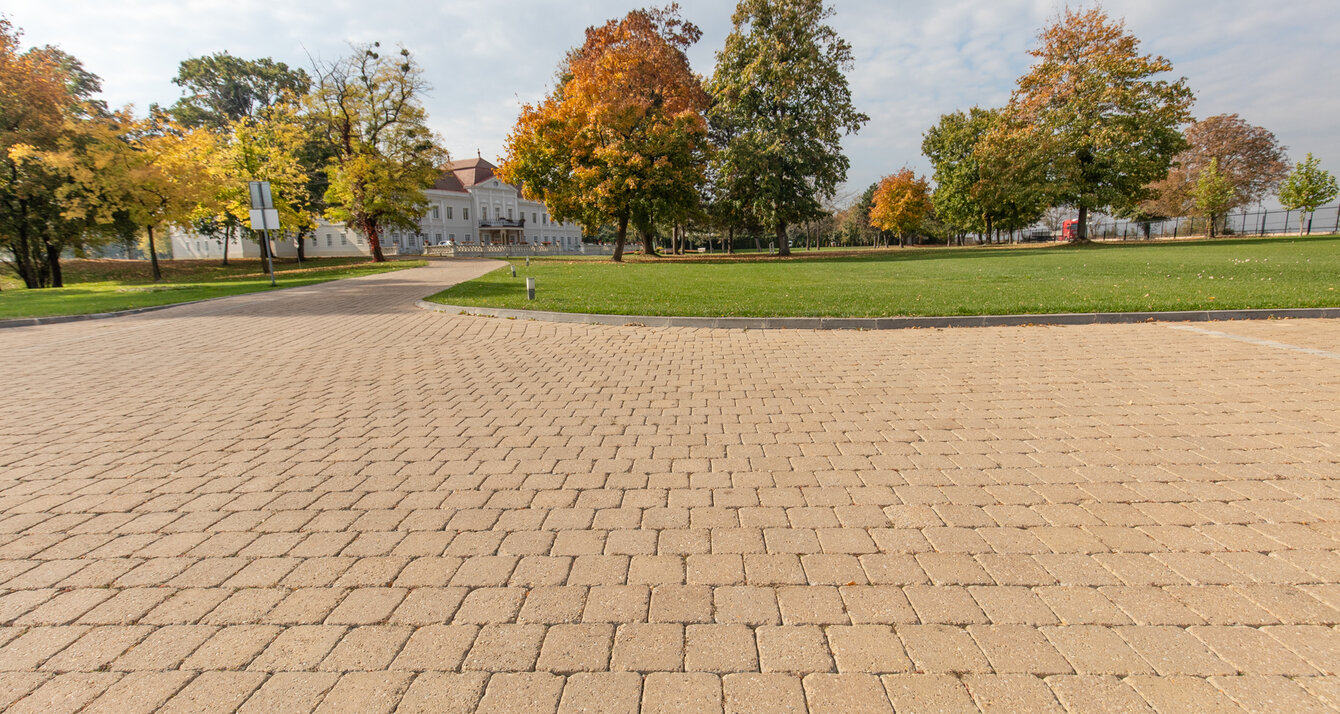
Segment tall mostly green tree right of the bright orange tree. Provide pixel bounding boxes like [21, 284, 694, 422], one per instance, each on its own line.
[709, 0, 870, 256]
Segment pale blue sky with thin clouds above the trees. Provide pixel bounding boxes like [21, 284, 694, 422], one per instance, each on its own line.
[4, 0, 1340, 206]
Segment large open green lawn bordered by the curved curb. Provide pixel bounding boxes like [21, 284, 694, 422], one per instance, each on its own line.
[430, 236, 1340, 317]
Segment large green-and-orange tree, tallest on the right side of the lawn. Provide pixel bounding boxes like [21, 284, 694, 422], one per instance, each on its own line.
[1005, 8, 1193, 241]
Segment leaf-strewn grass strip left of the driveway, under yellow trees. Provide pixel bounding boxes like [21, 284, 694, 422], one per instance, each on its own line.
[0, 257, 425, 319]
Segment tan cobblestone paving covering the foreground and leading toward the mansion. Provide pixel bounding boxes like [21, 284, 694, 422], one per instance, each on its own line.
[0, 263, 1340, 713]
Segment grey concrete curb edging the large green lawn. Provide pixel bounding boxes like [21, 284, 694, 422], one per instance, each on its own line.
[418, 300, 1340, 330]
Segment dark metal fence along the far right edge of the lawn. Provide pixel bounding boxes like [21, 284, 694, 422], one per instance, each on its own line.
[1089, 204, 1340, 240]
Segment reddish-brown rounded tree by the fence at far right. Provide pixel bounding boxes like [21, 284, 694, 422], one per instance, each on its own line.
[1139, 114, 1289, 217]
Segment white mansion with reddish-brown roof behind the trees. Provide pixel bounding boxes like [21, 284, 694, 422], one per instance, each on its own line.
[172, 158, 582, 259]
